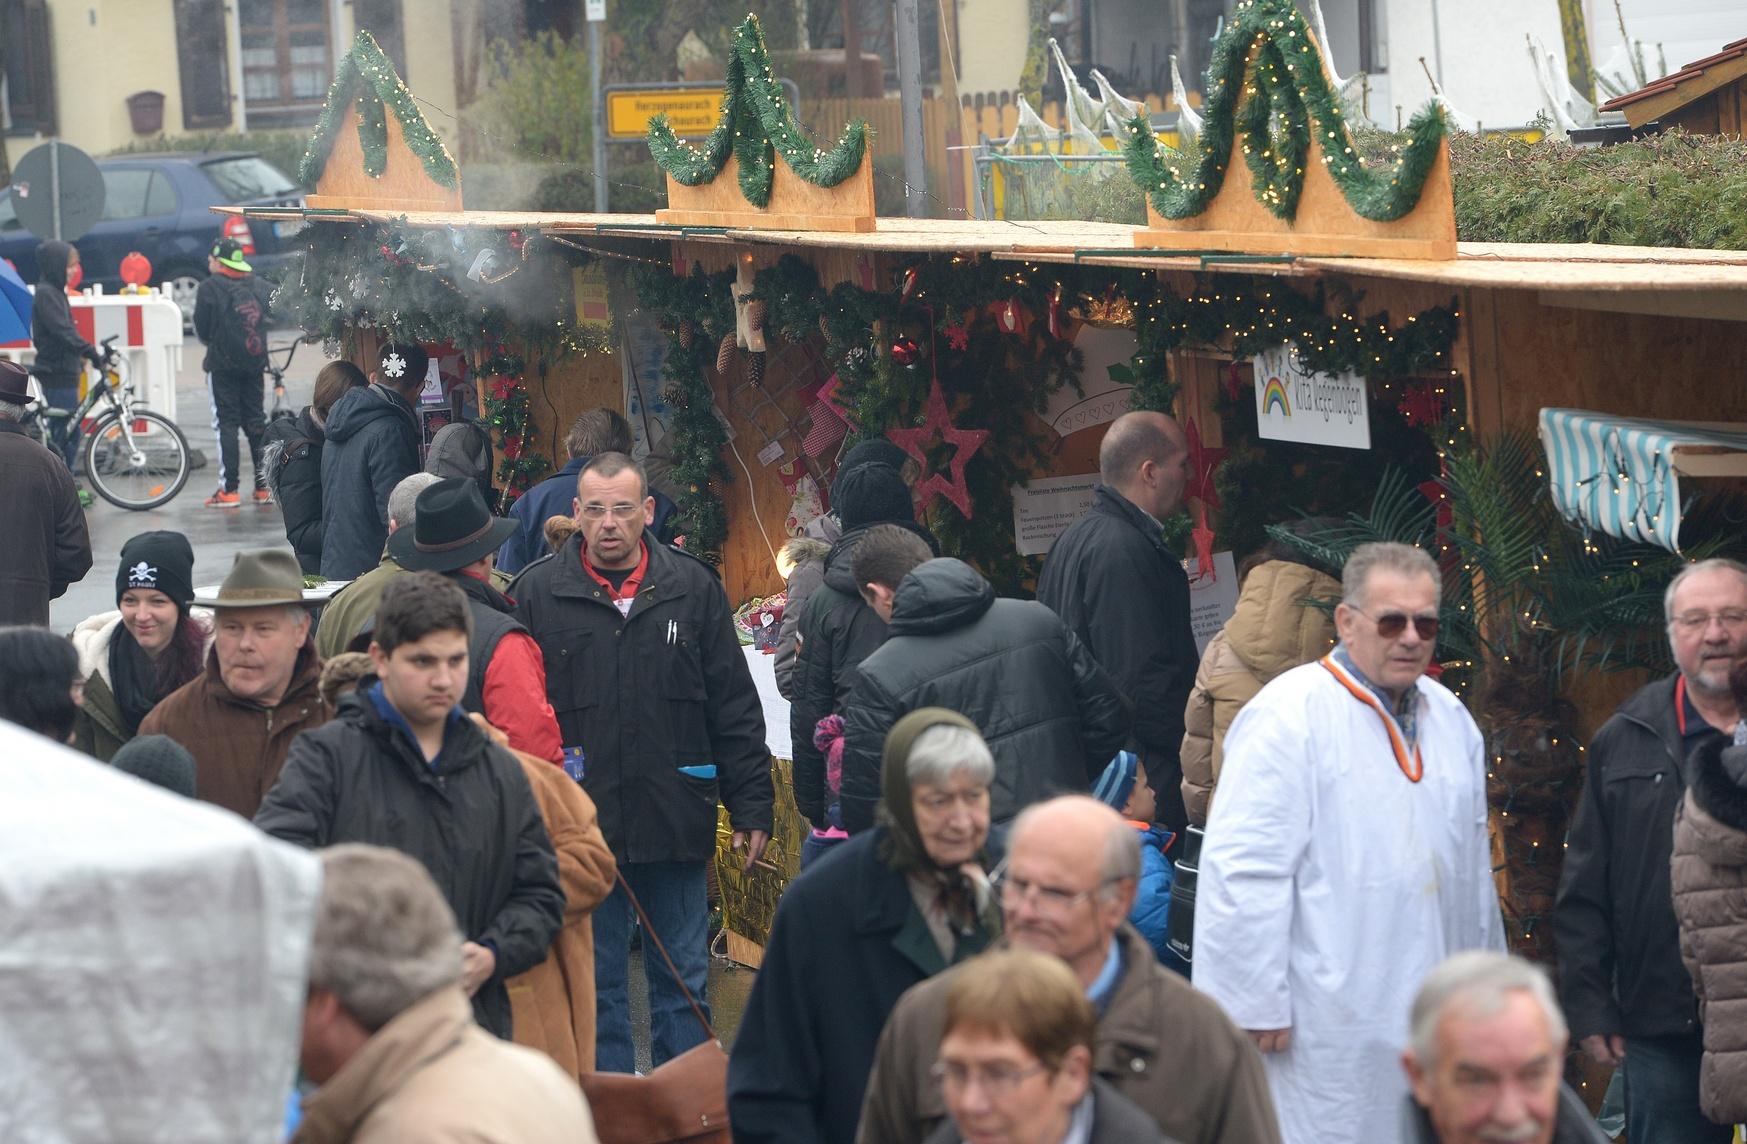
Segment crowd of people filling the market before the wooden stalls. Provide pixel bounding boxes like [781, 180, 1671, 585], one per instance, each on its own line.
[0, 382, 1747, 1144]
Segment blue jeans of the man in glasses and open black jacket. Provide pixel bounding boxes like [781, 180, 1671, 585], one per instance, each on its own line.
[594, 863, 709, 1072]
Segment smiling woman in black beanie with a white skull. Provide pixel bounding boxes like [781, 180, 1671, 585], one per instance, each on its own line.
[73, 533, 211, 762]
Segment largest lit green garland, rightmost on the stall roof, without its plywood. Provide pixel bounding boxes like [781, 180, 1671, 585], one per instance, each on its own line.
[1123, 0, 1448, 222]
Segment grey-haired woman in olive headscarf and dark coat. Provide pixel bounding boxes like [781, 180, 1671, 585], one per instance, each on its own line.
[728, 707, 999, 1144]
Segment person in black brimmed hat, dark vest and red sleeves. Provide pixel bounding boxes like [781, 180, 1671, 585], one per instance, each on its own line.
[388, 477, 564, 763]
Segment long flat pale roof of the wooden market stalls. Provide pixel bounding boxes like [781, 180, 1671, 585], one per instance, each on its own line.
[229, 208, 1747, 302]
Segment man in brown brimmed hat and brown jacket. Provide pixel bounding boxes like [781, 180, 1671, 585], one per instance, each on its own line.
[140, 548, 332, 817]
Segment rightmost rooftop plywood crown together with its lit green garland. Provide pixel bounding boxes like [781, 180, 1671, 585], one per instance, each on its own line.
[1123, 0, 1455, 258]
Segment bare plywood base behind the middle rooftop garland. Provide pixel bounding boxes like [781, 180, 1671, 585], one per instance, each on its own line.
[655, 155, 874, 232]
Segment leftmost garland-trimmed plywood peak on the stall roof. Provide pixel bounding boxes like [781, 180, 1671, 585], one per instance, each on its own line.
[299, 31, 461, 211]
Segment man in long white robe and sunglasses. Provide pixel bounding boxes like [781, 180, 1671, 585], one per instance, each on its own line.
[1193, 543, 1504, 1144]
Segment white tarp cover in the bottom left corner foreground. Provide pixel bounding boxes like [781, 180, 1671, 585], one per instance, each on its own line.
[0, 723, 321, 1144]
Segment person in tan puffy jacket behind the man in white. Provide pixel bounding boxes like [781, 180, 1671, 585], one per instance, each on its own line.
[1183, 541, 1340, 826]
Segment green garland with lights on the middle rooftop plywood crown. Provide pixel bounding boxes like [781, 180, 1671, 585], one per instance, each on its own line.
[648, 16, 872, 208]
